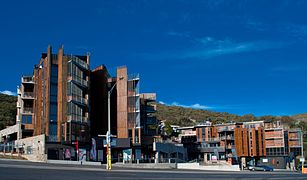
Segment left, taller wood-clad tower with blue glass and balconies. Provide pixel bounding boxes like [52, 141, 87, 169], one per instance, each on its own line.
[17, 46, 89, 148]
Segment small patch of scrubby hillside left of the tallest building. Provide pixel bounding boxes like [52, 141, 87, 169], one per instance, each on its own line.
[0, 93, 17, 130]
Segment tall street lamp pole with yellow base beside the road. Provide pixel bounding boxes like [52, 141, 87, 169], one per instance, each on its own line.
[106, 77, 124, 170]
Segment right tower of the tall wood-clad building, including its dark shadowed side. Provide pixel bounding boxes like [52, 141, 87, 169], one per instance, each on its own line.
[90, 66, 158, 161]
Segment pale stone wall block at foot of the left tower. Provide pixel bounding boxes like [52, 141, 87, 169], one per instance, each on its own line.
[15, 134, 47, 162]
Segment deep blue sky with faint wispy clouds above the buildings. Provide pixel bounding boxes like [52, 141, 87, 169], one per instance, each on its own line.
[0, 0, 307, 116]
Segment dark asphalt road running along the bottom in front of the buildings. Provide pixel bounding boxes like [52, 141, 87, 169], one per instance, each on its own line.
[0, 160, 307, 180]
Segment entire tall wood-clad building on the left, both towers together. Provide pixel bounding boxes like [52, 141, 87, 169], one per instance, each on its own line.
[1, 46, 158, 160]
